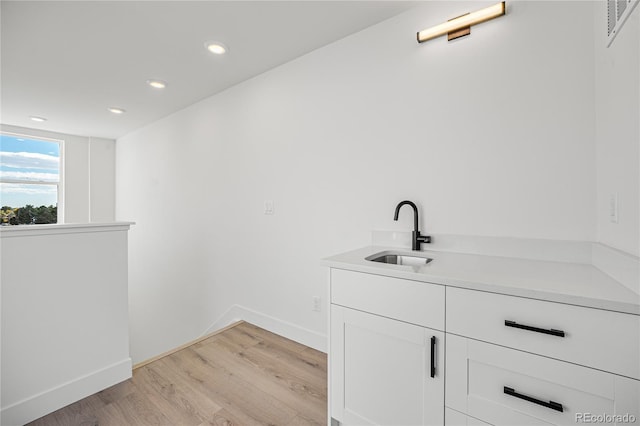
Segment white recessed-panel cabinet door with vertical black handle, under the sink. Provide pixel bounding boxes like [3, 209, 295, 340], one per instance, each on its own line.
[330, 305, 444, 425]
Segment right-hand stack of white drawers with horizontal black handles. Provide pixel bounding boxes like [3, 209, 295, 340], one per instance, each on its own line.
[445, 287, 640, 426]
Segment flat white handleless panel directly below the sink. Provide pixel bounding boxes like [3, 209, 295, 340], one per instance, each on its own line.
[331, 269, 445, 330]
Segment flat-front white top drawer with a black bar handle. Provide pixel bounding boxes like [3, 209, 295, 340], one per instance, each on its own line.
[447, 287, 640, 379]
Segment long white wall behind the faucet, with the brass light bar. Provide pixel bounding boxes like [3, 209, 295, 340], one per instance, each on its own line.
[116, 2, 596, 362]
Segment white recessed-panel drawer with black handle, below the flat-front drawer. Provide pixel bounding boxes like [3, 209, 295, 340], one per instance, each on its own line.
[445, 335, 640, 426]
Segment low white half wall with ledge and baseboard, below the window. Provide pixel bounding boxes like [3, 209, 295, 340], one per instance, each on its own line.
[0, 224, 131, 426]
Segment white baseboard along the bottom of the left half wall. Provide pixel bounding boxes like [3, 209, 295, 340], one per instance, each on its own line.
[0, 358, 131, 426]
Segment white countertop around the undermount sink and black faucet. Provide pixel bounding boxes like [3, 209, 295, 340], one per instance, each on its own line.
[323, 246, 640, 315]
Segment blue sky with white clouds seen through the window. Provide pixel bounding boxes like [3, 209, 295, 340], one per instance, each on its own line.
[0, 134, 60, 208]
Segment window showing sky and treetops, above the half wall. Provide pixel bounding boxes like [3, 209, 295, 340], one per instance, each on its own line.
[0, 133, 62, 225]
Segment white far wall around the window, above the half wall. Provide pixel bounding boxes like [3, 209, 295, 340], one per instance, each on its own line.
[0, 124, 115, 223]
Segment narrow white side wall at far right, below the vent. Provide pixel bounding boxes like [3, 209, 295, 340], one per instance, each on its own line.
[595, 2, 640, 256]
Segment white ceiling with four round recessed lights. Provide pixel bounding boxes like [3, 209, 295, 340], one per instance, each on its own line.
[0, 0, 412, 139]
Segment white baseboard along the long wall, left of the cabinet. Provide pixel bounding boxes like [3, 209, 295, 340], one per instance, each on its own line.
[202, 305, 327, 353]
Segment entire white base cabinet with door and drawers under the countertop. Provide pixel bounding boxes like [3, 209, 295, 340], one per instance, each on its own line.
[329, 262, 640, 426]
